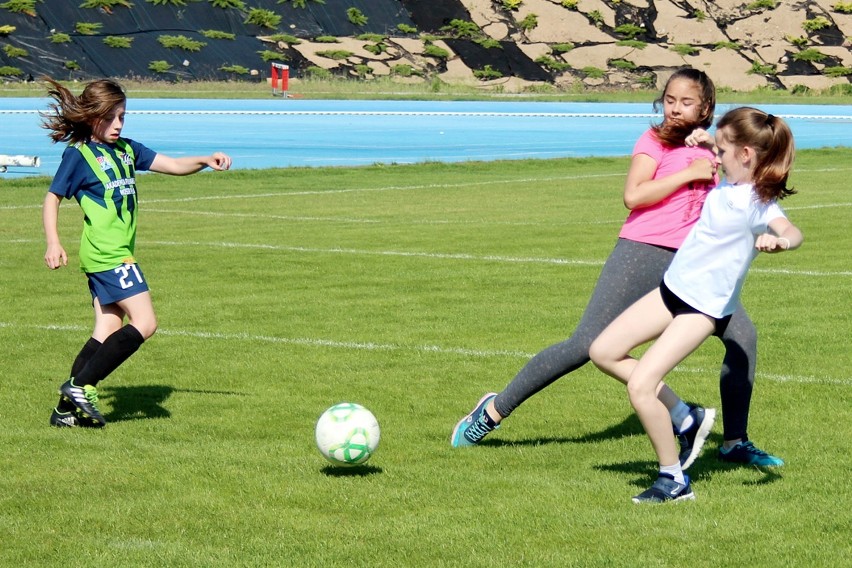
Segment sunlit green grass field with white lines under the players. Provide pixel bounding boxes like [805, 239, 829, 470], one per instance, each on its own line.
[0, 149, 852, 567]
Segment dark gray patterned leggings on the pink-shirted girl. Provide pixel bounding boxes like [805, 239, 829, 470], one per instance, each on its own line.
[494, 239, 757, 440]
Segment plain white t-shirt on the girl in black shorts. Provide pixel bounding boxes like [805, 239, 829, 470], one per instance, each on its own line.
[663, 182, 785, 318]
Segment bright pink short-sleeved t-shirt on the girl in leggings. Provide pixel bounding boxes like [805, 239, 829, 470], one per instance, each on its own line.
[618, 128, 719, 249]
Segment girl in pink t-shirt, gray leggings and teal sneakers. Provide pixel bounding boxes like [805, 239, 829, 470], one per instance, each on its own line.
[450, 68, 784, 468]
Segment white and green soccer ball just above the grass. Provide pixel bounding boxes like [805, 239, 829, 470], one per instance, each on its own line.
[316, 402, 381, 466]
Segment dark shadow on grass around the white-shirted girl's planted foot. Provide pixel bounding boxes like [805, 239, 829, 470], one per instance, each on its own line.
[595, 432, 784, 487]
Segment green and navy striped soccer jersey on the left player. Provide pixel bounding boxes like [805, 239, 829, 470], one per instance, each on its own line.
[50, 138, 157, 272]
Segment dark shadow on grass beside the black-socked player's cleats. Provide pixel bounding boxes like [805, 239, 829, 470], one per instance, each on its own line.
[99, 385, 243, 422]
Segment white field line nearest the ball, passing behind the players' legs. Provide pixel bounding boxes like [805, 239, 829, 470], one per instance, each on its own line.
[5, 321, 852, 386]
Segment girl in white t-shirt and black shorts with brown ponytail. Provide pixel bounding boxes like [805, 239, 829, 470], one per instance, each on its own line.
[589, 107, 803, 503]
